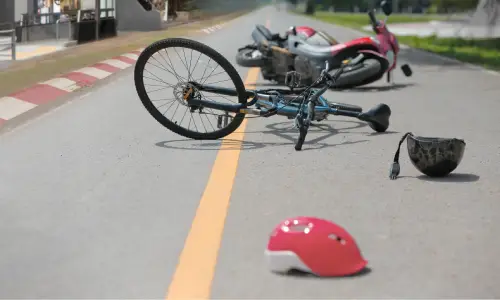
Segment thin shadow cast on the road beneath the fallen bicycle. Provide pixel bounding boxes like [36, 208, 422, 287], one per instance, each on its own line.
[156, 120, 397, 151]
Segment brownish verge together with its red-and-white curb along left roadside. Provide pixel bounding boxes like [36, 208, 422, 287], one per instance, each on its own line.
[0, 12, 246, 131]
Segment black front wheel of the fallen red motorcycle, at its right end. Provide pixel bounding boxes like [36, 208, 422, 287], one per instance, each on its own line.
[330, 59, 383, 89]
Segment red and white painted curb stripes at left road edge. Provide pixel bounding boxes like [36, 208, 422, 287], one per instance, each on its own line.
[0, 49, 143, 128]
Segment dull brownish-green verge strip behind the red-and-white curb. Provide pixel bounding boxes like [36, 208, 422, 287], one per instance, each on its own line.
[0, 12, 245, 97]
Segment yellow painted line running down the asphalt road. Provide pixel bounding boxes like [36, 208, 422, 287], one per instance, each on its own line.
[166, 68, 260, 299]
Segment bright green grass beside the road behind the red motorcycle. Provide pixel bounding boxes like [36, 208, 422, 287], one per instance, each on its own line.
[304, 12, 500, 70]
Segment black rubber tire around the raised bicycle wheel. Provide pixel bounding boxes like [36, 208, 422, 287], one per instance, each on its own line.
[134, 38, 247, 140]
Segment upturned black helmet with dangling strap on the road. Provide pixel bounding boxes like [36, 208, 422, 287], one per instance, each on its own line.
[389, 132, 465, 179]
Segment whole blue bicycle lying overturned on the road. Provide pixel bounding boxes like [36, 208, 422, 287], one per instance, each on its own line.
[134, 38, 391, 151]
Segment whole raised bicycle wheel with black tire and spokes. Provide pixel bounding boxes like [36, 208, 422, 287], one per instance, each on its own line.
[134, 38, 247, 140]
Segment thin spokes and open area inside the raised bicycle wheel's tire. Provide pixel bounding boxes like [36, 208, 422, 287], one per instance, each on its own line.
[142, 39, 243, 137]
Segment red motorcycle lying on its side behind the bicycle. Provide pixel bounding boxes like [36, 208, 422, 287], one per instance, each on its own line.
[236, 1, 412, 89]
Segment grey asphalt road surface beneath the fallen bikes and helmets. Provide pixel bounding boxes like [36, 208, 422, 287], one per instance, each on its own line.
[0, 8, 500, 299]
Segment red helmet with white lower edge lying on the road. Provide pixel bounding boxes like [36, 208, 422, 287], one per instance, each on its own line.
[265, 217, 368, 276]
